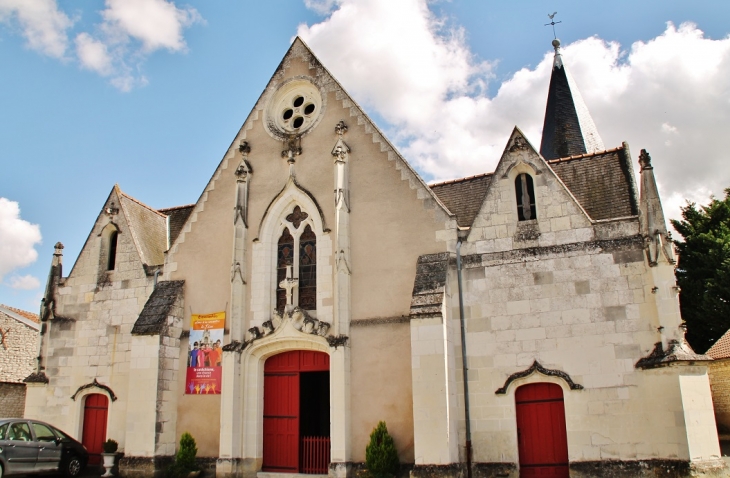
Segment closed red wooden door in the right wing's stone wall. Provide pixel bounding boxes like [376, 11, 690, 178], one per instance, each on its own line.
[515, 383, 569, 478]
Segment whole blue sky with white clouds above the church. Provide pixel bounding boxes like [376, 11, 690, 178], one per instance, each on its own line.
[0, 0, 730, 311]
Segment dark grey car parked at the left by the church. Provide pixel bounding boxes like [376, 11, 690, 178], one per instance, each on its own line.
[0, 418, 89, 478]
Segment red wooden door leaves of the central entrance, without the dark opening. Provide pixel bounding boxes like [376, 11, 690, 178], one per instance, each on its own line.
[263, 350, 329, 473]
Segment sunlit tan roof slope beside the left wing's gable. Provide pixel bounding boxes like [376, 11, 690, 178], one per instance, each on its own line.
[119, 190, 167, 266]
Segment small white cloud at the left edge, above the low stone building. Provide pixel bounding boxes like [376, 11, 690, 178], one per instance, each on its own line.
[0, 197, 41, 280]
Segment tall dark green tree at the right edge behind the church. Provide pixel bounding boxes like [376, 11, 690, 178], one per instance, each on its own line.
[672, 188, 730, 353]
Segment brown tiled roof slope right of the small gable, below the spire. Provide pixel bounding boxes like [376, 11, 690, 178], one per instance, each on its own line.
[548, 147, 639, 220]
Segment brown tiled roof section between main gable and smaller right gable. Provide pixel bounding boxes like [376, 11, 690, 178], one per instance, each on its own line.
[429, 173, 492, 227]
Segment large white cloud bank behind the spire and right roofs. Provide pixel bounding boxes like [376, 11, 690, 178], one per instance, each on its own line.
[298, 0, 730, 222]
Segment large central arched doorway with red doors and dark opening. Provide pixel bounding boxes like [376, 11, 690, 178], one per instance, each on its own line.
[262, 350, 330, 474]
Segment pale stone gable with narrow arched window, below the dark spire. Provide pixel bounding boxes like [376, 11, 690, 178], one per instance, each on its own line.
[468, 127, 593, 252]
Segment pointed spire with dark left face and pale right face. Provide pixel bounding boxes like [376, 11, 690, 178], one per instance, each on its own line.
[540, 38, 605, 159]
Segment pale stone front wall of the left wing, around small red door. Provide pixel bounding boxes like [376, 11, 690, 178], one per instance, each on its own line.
[26, 192, 157, 451]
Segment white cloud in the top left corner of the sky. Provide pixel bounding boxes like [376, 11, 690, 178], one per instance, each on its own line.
[0, 0, 73, 58]
